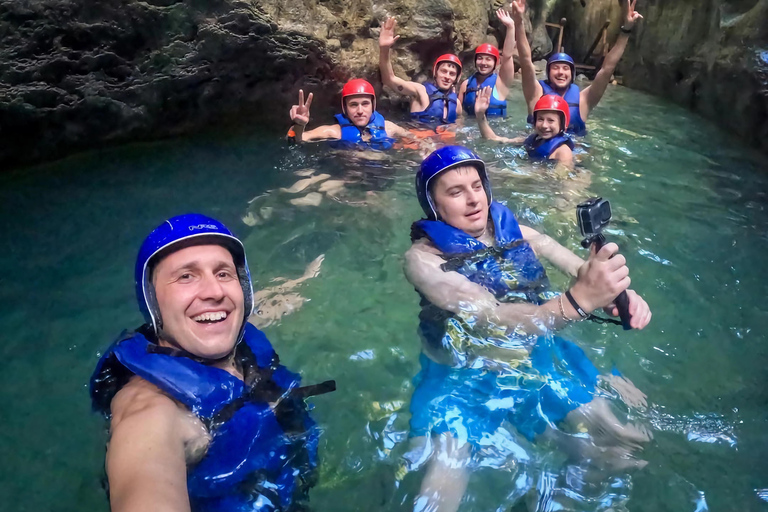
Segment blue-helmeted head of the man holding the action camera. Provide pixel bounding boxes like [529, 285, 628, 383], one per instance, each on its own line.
[416, 146, 492, 237]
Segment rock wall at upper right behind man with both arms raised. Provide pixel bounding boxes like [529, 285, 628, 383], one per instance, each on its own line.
[550, 0, 768, 152]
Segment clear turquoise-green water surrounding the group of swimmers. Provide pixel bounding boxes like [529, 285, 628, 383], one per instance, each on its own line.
[0, 88, 768, 511]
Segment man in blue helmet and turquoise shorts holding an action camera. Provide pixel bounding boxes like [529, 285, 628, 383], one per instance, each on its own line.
[405, 146, 651, 511]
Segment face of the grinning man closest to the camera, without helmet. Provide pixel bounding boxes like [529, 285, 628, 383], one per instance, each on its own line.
[152, 245, 245, 359]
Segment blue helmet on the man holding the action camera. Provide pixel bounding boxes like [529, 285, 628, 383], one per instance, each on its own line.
[416, 146, 492, 220]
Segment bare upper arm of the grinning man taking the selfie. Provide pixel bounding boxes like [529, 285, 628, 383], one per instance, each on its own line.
[106, 381, 190, 512]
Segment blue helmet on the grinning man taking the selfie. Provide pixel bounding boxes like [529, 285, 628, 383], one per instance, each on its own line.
[135, 213, 253, 342]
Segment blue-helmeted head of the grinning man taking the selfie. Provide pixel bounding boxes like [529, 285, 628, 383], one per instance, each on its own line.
[135, 213, 253, 360]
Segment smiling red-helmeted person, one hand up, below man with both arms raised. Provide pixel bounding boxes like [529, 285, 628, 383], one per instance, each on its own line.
[475, 87, 573, 168]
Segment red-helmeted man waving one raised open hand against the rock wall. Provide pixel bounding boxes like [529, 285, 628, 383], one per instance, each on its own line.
[379, 18, 461, 124]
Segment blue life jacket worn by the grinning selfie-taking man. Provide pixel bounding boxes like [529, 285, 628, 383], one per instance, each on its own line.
[91, 324, 331, 512]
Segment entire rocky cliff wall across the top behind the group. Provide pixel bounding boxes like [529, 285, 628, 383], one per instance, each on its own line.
[0, 0, 768, 168]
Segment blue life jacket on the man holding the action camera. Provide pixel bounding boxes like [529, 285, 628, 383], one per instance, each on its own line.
[411, 202, 549, 366]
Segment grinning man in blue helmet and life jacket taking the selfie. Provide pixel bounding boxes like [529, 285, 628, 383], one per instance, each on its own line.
[91, 214, 333, 511]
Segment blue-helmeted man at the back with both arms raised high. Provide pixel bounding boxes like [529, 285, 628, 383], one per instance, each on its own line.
[512, 0, 643, 136]
